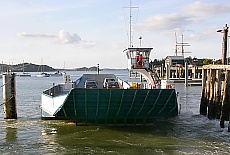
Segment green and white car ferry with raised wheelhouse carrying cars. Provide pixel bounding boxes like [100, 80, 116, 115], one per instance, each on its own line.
[41, 48, 179, 126]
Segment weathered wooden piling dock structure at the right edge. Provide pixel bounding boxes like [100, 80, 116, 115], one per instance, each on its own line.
[200, 65, 230, 132]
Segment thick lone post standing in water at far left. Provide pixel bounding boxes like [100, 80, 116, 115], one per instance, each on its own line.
[3, 73, 17, 119]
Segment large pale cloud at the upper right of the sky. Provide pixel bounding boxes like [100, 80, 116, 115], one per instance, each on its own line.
[140, 1, 230, 35]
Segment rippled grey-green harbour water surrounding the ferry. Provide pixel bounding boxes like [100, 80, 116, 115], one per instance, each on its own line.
[0, 70, 230, 155]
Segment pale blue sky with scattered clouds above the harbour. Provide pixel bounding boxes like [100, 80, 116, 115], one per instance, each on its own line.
[0, 0, 230, 68]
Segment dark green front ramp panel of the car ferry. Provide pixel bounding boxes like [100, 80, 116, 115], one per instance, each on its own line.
[55, 88, 178, 125]
